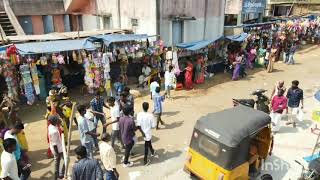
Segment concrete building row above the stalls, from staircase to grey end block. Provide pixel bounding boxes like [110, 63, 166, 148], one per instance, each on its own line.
[0, 0, 224, 45]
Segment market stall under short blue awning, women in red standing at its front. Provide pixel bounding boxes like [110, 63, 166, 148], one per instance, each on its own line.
[172, 37, 224, 89]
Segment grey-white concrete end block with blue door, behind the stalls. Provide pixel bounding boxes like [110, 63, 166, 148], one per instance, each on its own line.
[157, 0, 224, 45]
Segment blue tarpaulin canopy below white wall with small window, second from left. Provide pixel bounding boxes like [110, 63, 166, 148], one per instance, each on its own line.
[88, 34, 148, 46]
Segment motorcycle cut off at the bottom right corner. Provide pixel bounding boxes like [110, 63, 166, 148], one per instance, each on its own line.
[295, 158, 320, 180]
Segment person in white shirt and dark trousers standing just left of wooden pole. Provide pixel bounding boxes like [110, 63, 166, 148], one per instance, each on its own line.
[48, 115, 65, 179]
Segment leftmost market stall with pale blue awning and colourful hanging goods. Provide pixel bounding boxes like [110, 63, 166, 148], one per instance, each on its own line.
[0, 40, 95, 105]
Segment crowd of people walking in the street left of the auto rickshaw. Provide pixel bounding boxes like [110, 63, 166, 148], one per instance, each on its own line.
[43, 81, 170, 180]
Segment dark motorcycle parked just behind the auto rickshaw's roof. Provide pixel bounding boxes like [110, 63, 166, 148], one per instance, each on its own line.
[232, 89, 270, 114]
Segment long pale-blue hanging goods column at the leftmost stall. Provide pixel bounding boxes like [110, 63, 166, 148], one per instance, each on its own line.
[20, 64, 35, 105]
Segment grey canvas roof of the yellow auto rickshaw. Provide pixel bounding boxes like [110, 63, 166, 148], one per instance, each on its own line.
[195, 105, 271, 147]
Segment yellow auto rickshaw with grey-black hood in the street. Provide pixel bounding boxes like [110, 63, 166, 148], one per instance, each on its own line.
[184, 105, 273, 180]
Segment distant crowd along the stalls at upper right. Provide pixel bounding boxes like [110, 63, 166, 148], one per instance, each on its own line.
[226, 19, 320, 80]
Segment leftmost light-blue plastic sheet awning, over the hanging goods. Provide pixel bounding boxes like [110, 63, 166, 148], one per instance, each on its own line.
[15, 39, 96, 54]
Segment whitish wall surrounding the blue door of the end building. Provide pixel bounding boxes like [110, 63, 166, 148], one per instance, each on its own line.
[160, 0, 225, 46]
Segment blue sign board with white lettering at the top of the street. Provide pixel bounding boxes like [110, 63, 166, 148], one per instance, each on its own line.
[242, 0, 266, 13]
